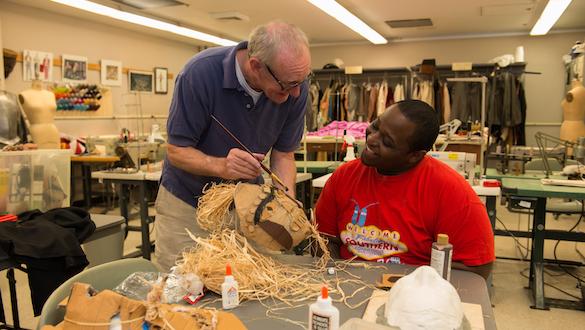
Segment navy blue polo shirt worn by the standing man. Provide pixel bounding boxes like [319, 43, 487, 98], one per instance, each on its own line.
[161, 41, 308, 207]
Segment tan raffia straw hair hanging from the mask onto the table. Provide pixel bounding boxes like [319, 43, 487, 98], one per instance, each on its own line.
[179, 184, 373, 311]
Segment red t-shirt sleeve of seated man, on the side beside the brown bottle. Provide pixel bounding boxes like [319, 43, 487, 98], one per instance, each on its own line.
[435, 183, 495, 266]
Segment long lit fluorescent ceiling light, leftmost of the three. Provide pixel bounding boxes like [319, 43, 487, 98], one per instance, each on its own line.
[51, 0, 237, 46]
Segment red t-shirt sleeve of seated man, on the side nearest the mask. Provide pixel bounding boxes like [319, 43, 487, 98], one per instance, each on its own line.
[315, 169, 339, 236]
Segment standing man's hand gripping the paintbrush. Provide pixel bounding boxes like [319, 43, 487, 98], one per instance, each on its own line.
[221, 148, 264, 179]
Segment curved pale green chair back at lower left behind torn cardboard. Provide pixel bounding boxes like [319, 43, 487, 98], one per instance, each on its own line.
[37, 258, 158, 330]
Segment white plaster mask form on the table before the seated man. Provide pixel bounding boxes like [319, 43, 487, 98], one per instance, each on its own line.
[384, 266, 463, 330]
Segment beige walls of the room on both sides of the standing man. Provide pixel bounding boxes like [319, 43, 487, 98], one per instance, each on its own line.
[0, 1, 585, 145]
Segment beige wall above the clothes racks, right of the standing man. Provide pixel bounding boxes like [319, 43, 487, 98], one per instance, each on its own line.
[311, 33, 585, 145]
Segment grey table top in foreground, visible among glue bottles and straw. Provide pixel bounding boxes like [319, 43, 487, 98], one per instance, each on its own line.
[206, 256, 496, 330]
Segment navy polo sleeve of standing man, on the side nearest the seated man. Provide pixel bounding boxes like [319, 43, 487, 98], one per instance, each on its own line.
[274, 82, 309, 152]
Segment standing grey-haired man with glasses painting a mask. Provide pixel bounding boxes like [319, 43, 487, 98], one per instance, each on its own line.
[155, 21, 311, 271]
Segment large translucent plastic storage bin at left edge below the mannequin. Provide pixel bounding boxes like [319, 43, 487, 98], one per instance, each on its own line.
[0, 149, 71, 214]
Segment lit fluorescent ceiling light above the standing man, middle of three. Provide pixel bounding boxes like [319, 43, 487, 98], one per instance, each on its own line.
[307, 0, 388, 45]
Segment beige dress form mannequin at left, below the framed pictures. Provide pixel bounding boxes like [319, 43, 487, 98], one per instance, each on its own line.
[18, 80, 61, 149]
